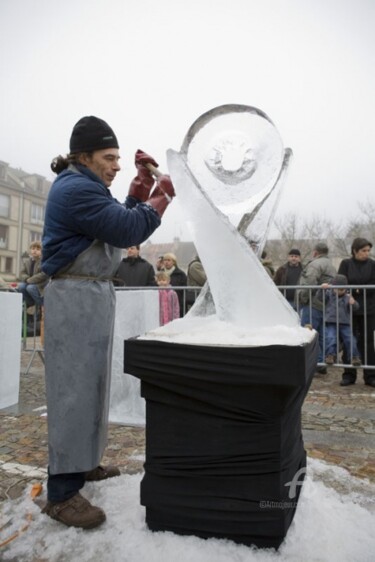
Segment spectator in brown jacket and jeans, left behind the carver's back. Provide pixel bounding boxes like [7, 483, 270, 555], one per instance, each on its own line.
[17, 241, 48, 308]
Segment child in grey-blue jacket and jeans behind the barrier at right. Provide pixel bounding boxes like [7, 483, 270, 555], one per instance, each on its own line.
[322, 275, 361, 367]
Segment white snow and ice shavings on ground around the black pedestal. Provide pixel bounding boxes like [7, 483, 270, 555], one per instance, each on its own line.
[0, 459, 375, 562]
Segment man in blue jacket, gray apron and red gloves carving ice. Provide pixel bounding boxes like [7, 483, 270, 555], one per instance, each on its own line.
[42, 116, 174, 529]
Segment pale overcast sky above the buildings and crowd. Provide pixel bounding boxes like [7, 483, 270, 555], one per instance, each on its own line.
[0, 0, 375, 242]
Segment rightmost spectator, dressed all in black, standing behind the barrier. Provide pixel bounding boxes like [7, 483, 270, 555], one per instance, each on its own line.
[338, 238, 375, 387]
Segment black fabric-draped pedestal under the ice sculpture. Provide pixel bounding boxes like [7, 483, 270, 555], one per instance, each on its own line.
[124, 338, 318, 548]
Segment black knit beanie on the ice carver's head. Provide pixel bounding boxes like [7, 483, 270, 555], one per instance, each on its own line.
[69, 115, 119, 154]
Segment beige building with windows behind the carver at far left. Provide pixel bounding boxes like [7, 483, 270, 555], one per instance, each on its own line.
[0, 160, 51, 281]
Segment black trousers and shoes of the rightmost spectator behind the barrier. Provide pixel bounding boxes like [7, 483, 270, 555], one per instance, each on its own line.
[342, 314, 375, 382]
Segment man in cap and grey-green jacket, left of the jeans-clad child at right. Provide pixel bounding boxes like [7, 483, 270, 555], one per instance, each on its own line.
[297, 242, 336, 375]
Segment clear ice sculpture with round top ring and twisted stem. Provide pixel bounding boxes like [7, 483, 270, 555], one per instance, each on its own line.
[157, 105, 299, 331]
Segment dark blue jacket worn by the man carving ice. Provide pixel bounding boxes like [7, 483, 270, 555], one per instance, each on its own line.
[42, 166, 160, 276]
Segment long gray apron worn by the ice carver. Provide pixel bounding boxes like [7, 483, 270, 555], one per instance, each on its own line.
[44, 240, 121, 474]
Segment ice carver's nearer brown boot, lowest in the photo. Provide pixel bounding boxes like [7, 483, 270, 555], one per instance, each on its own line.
[42, 492, 106, 529]
